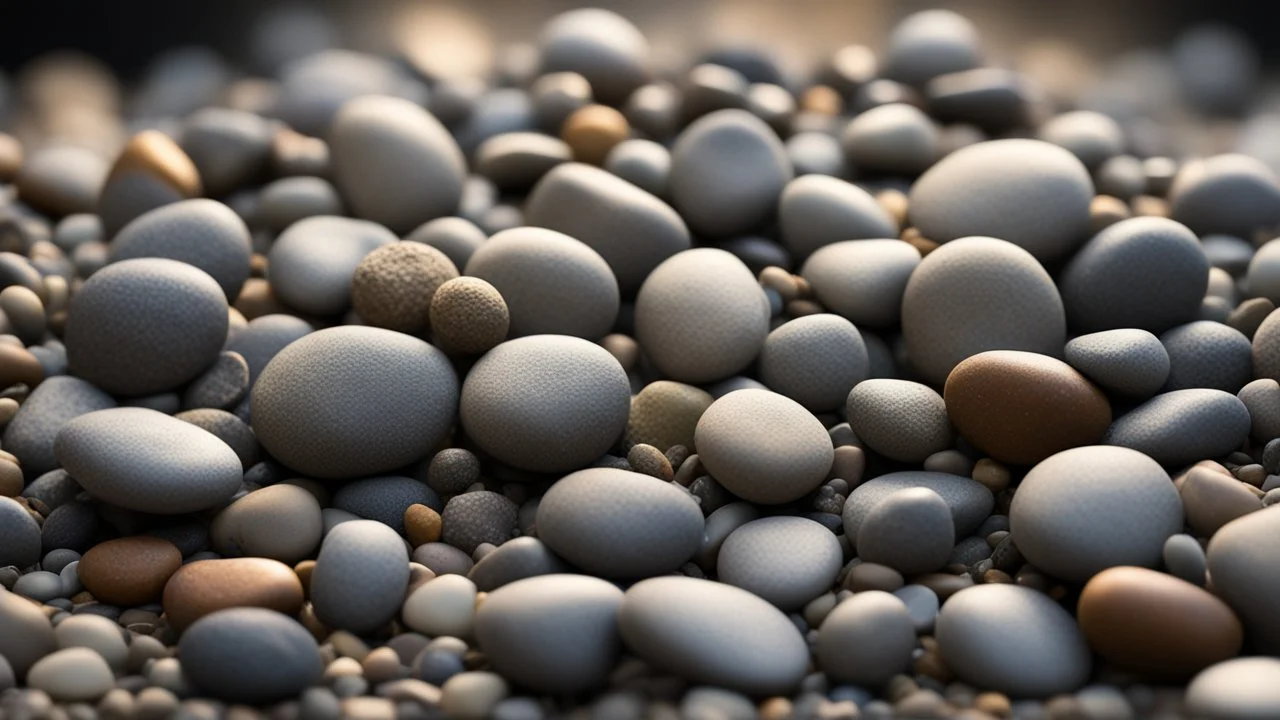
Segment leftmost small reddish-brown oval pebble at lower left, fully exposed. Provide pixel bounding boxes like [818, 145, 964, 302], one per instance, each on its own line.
[79, 536, 182, 607]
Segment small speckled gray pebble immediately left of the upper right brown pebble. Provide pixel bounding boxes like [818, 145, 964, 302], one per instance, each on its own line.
[846, 378, 954, 461]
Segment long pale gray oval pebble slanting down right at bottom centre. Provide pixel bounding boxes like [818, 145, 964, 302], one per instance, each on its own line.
[618, 577, 809, 694]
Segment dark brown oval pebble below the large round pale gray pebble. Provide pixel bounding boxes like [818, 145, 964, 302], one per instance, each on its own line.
[942, 350, 1111, 465]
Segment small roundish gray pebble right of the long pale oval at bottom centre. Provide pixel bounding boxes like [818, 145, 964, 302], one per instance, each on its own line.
[814, 591, 915, 687]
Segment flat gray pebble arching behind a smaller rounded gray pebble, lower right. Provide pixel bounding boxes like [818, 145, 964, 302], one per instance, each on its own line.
[842, 470, 996, 543]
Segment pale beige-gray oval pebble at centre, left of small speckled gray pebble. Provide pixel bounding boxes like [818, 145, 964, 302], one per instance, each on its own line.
[694, 389, 835, 505]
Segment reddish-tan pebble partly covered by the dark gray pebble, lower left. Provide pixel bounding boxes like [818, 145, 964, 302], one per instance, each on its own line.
[163, 557, 303, 632]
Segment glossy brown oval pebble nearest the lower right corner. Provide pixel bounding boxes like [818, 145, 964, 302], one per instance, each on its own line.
[1076, 568, 1244, 678]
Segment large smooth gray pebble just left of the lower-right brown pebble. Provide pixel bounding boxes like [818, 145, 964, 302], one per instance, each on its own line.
[936, 584, 1092, 698]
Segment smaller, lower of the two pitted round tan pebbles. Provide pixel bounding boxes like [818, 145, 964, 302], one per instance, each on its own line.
[430, 277, 511, 355]
